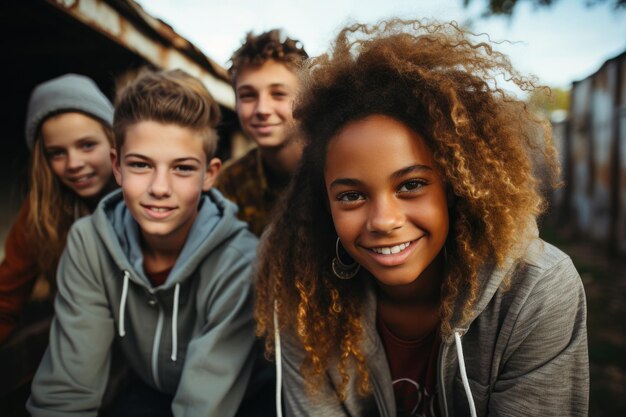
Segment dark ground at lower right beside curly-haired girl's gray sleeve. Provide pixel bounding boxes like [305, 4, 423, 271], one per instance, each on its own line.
[541, 222, 626, 417]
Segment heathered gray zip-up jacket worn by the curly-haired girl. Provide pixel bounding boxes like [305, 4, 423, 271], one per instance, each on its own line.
[277, 239, 589, 417]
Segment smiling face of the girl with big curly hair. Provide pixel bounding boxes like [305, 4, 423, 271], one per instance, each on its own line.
[324, 115, 449, 286]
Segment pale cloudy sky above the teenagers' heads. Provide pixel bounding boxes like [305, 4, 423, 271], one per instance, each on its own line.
[138, 0, 626, 88]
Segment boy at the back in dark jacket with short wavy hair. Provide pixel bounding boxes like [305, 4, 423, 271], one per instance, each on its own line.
[216, 29, 308, 236]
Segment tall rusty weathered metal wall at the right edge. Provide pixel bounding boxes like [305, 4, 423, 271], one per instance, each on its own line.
[554, 48, 626, 252]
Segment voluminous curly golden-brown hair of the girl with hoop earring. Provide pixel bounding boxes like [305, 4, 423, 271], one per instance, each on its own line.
[255, 20, 559, 398]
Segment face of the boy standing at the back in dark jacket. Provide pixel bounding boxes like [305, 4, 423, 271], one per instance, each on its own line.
[235, 60, 298, 148]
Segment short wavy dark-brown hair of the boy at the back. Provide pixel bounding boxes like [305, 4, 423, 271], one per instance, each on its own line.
[228, 29, 309, 86]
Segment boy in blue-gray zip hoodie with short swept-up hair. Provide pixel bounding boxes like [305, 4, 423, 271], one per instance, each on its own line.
[27, 70, 257, 417]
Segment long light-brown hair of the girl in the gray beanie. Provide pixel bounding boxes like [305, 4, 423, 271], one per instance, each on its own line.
[26, 118, 115, 282]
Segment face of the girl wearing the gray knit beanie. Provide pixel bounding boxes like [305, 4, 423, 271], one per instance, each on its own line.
[41, 112, 111, 199]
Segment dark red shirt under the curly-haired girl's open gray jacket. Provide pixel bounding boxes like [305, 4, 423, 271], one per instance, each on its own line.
[377, 316, 441, 417]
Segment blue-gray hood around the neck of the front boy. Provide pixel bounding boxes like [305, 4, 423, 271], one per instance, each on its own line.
[93, 189, 246, 291]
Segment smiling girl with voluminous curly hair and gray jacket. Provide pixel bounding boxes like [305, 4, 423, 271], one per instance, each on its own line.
[256, 20, 588, 416]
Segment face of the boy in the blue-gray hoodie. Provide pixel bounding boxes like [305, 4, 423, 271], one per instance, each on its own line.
[113, 121, 221, 250]
